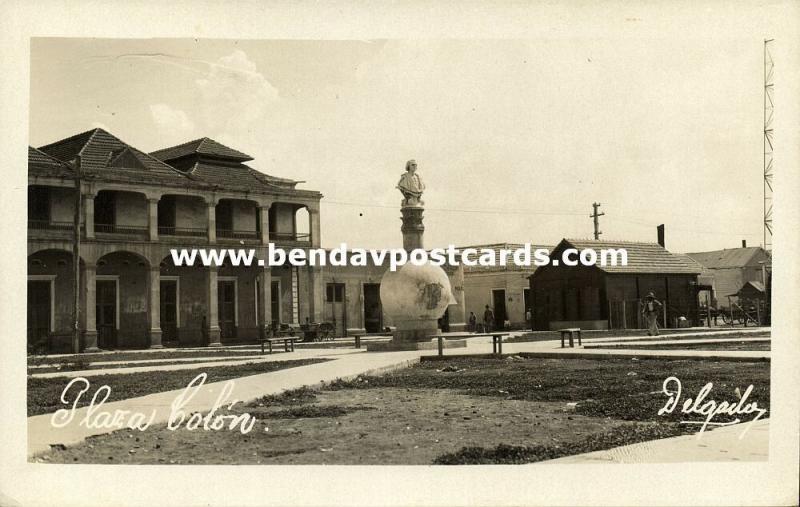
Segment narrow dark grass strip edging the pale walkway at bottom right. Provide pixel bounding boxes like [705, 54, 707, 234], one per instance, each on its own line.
[433, 424, 691, 465]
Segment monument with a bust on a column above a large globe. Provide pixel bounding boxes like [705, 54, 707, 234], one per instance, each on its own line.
[367, 160, 466, 350]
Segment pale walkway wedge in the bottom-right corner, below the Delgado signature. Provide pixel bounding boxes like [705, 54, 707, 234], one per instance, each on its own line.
[545, 419, 769, 464]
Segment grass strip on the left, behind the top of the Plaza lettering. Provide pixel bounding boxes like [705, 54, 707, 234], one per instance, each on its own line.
[28, 358, 328, 417]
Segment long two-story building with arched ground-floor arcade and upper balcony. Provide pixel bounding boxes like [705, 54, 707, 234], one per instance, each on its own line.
[28, 129, 324, 350]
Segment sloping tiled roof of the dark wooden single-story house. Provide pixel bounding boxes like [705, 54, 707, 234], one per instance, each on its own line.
[556, 239, 701, 274]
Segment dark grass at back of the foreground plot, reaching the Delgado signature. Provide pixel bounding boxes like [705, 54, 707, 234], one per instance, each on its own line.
[326, 358, 770, 422]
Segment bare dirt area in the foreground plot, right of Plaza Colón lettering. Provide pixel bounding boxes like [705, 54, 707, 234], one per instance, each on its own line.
[40, 388, 642, 465]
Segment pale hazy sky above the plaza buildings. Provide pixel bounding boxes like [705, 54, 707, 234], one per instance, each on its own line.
[30, 37, 763, 252]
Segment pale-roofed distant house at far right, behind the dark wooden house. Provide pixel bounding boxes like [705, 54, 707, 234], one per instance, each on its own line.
[687, 247, 772, 308]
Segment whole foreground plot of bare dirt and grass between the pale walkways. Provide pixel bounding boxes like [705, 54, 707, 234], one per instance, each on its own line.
[35, 356, 770, 465]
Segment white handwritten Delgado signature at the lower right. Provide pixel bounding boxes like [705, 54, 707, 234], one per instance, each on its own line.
[658, 377, 767, 439]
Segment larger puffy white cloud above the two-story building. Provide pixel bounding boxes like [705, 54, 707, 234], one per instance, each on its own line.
[195, 49, 278, 139]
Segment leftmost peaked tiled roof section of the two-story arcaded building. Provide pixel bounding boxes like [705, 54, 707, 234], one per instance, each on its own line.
[39, 128, 188, 182]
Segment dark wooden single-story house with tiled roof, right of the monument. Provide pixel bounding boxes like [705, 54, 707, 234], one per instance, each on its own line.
[530, 239, 701, 330]
